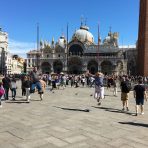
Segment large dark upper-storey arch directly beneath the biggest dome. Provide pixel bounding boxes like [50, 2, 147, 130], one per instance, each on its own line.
[69, 44, 83, 56]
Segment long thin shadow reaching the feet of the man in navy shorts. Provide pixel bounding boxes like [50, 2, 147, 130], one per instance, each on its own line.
[92, 106, 133, 115]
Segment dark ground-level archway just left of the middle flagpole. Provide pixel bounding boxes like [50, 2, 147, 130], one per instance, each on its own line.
[53, 60, 63, 74]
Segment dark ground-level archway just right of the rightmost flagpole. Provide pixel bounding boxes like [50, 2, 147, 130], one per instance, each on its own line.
[101, 61, 114, 74]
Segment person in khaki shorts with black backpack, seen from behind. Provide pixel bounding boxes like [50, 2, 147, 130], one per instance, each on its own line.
[120, 76, 131, 111]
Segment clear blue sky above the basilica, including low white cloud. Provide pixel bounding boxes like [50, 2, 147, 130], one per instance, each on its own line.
[0, 0, 139, 57]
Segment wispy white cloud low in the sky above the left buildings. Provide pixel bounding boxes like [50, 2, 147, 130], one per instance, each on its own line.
[9, 39, 36, 58]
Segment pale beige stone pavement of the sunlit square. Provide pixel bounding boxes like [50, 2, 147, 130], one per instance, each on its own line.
[0, 81, 148, 148]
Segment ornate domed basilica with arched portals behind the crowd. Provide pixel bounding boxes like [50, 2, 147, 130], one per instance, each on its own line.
[26, 25, 137, 75]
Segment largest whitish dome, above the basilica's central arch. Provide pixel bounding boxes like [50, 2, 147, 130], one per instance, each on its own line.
[72, 26, 94, 43]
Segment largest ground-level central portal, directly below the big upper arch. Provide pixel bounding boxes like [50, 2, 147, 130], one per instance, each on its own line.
[68, 57, 83, 74]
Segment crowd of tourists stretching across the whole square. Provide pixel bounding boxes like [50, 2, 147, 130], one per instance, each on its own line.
[0, 67, 148, 116]
